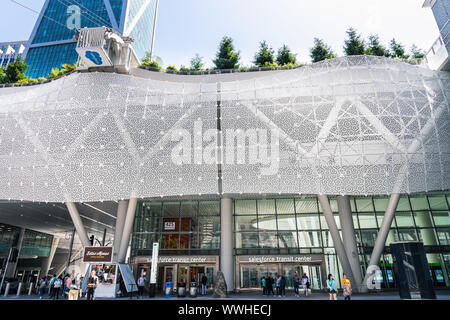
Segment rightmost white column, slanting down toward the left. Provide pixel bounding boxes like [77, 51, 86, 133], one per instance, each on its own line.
[361, 193, 400, 292]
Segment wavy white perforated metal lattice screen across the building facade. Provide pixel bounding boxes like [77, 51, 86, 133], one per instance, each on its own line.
[0, 56, 450, 201]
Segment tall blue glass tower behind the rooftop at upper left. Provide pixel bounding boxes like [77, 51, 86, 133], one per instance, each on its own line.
[26, 0, 158, 78]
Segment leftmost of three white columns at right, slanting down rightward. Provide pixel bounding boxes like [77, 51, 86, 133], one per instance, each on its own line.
[317, 194, 356, 283]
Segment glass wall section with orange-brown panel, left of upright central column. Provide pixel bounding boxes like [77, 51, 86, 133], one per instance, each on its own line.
[132, 201, 220, 257]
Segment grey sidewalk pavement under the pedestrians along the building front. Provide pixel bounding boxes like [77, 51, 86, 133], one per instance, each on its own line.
[0, 290, 450, 301]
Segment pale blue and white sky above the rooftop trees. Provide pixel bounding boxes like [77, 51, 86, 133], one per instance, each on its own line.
[0, 0, 439, 67]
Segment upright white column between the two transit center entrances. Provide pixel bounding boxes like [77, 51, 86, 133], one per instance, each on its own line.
[220, 198, 234, 292]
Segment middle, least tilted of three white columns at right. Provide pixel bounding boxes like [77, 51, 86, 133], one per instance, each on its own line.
[336, 196, 362, 291]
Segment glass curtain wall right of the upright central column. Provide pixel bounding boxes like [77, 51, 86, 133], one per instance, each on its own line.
[233, 192, 450, 287]
